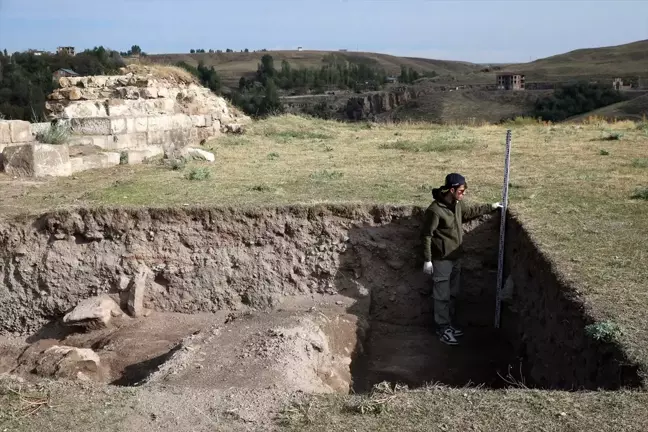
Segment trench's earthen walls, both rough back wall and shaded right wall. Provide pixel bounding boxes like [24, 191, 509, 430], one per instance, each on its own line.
[0, 205, 642, 389]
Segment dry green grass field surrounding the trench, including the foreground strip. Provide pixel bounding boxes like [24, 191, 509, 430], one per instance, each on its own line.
[0, 116, 648, 431]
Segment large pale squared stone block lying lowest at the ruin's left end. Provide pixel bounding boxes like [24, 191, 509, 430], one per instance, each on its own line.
[2, 144, 72, 177]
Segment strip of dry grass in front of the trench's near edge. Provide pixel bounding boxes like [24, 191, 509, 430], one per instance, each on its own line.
[280, 386, 648, 432]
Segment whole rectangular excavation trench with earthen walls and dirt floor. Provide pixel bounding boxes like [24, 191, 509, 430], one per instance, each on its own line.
[0, 206, 642, 392]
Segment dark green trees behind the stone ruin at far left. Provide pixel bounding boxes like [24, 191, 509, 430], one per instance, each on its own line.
[0, 46, 124, 121]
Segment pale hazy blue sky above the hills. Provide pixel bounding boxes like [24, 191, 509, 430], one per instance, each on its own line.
[0, 0, 648, 62]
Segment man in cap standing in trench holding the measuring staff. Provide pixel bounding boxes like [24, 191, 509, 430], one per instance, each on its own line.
[422, 173, 501, 345]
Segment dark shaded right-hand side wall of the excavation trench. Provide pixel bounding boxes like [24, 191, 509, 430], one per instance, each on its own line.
[502, 216, 643, 390]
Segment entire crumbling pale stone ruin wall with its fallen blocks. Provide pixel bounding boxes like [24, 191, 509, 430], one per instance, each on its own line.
[0, 68, 250, 177]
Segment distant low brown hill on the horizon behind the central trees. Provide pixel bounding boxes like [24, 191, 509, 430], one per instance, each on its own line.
[148, 51, 480, 85]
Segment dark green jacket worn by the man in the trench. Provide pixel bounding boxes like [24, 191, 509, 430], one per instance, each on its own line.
[421, 189, 493, 261]
